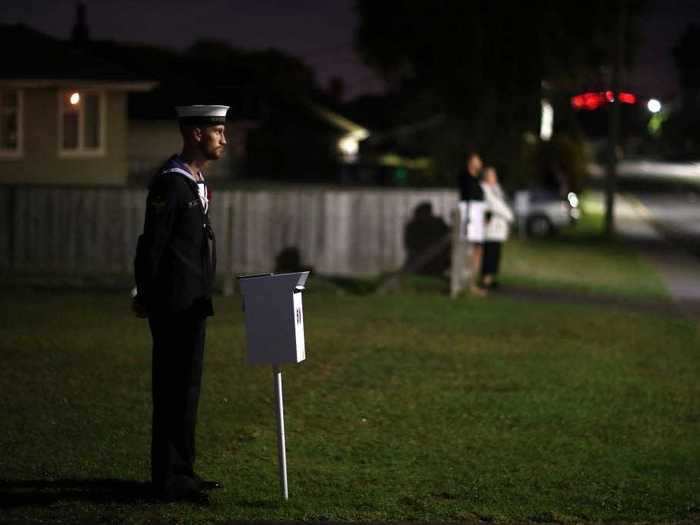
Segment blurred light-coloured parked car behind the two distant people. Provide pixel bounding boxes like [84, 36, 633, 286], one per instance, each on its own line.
[513, 189, 581, 237]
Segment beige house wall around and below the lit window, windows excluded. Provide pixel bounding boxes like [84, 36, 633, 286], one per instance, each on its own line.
[0, 87, 127, 186]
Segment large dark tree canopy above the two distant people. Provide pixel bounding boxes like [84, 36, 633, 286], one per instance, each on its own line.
[355, 0, 641, 194]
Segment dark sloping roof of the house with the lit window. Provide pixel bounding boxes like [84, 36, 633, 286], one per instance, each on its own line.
[0, 24, 156, 91]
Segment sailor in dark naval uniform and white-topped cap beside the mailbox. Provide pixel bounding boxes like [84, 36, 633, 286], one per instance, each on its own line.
[133, 106, 228, 501]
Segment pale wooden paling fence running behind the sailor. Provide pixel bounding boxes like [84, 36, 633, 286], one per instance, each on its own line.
[0, 186, 457, 276]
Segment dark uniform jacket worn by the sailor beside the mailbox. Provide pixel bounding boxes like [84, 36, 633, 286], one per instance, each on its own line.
[134, 156, 216, 316]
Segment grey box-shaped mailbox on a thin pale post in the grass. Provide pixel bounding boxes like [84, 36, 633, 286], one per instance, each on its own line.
[239, 272, 309, 500]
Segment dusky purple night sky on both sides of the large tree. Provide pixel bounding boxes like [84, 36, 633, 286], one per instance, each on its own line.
[0, 0, 700, 98]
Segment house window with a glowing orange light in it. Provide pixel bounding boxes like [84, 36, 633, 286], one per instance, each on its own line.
[59, 90, 105, 156]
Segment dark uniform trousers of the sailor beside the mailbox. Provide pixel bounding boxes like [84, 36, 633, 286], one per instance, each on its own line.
[148, 311, 206, 496]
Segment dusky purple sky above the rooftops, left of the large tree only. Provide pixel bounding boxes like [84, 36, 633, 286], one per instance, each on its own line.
[0, 0, 383, 98]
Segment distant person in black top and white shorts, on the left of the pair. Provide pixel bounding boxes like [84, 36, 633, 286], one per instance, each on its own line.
[457, 153, 486, 296]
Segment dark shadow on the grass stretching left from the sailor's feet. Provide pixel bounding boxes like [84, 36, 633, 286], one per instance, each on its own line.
[0, 479, 156, 509]
